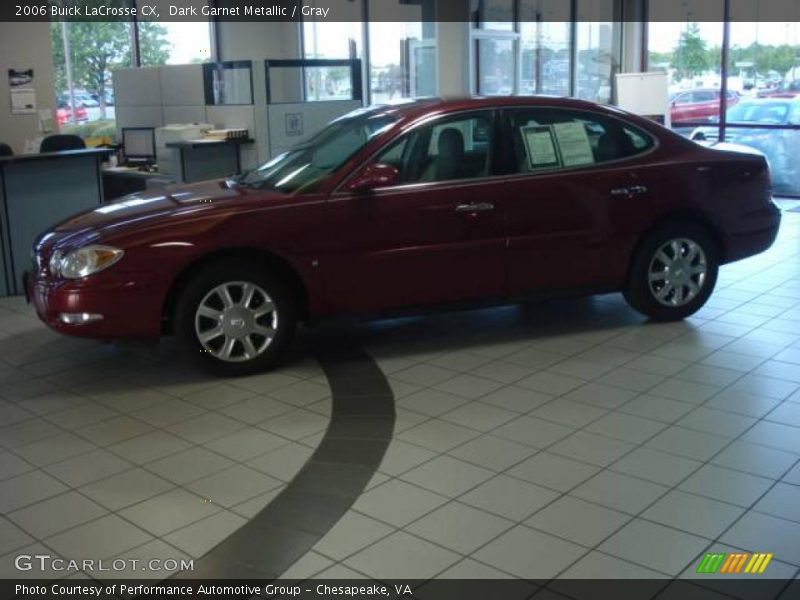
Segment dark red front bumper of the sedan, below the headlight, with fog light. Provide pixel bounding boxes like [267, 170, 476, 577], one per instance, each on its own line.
[24, 273, 164, 338]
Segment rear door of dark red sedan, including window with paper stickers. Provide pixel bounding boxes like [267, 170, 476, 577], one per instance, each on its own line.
[500, 107, 661, 295]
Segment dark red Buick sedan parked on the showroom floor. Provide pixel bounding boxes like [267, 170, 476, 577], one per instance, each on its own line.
[27, 98, 780, 374]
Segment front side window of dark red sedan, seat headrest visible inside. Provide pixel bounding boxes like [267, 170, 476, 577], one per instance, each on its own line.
[375, 112, 493, 184]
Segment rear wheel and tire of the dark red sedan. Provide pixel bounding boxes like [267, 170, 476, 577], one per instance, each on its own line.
[623, 222, 719, 321]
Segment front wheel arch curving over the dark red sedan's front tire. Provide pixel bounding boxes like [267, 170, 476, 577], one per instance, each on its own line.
[161, 247, 310, 334]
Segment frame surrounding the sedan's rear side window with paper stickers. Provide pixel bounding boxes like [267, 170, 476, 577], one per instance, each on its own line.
[500, 104, 661, 180]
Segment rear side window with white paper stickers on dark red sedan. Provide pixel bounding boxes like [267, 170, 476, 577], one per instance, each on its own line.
[509, 108, 655, 173]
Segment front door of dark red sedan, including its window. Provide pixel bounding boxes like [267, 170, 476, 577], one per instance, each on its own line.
[320, 110, 506, 312]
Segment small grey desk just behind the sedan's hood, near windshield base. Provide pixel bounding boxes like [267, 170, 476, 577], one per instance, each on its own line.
[158, 138, 255, 183]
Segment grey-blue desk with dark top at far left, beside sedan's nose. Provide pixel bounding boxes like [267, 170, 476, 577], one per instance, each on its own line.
[0, 148, 114, 296]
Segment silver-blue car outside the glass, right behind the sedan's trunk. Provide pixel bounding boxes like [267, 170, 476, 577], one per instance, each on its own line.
[690, 97, 800, 196]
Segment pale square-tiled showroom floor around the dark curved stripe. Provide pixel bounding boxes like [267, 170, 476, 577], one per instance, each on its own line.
[0, 203, 800, 594]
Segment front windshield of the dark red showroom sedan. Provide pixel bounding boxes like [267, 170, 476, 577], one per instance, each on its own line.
[237, 109, 397, 194]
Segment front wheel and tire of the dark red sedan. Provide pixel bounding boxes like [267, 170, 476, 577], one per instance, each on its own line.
[175, 261, 297, 377]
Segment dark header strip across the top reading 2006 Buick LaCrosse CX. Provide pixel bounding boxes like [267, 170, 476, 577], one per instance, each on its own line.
[0, 0, 800, 23]
